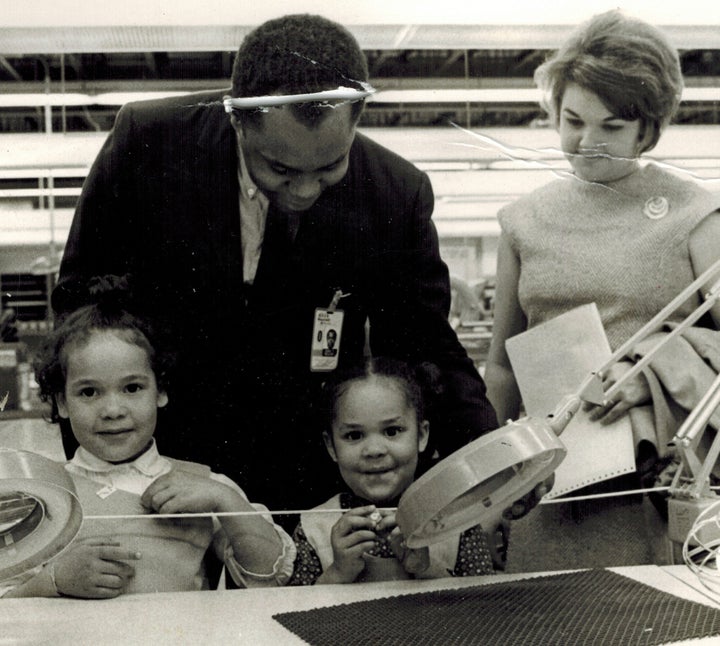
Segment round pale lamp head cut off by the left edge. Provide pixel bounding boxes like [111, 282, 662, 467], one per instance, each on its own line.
[0, 449, 82, 581]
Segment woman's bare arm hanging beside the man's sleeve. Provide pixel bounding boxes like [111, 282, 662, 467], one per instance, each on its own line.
[485, 234, 527, 425]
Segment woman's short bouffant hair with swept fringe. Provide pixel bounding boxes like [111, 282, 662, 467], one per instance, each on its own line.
[535, 10, 683, 152]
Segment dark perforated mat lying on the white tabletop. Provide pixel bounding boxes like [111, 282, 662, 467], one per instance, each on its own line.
[274, 570, 720, 646]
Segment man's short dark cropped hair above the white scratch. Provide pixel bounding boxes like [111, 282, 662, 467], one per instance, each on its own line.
[232, 14, 368, 128]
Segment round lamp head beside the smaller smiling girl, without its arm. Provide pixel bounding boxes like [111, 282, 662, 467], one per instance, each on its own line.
[396, 417, 567, 548]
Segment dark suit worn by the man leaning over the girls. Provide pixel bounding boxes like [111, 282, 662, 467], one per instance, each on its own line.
[53, 93, 496, 509]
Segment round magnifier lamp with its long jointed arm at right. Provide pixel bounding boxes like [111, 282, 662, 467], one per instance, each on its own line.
[397, 260, 720, 547]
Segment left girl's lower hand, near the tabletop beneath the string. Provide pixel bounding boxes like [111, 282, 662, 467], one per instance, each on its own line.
[49, 537, 140, 599]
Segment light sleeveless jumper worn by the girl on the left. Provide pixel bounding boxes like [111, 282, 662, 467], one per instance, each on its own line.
[71, 458, 214, 594]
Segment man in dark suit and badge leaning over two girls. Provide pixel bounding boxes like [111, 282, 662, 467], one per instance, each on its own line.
[53, 15, 497, 510]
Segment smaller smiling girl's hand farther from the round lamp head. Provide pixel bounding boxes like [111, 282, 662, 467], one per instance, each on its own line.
[325, 505, 377, 583]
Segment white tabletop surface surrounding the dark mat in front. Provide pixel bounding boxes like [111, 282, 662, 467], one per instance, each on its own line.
[0, 565, 720, 646]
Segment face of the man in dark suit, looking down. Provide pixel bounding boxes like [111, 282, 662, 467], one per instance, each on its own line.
[235, 103, 355, 212]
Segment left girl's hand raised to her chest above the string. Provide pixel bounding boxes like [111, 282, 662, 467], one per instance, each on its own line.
[140, 469, 231, 514]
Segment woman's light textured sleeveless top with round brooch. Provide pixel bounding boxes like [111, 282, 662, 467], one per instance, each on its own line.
[498, 163, 720, 349]
